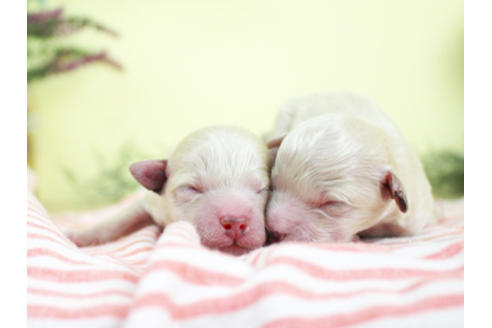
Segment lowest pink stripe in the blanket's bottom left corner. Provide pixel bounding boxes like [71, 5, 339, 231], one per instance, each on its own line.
[27, 304, 128, 319]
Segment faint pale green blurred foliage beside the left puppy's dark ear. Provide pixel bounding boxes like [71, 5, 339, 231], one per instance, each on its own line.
[62, 142, 148, 206]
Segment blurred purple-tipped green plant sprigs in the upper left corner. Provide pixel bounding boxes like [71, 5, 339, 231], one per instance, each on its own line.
[27, 8, 122, 83]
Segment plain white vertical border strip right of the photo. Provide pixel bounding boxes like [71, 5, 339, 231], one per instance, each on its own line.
[465, 1, 492, 327]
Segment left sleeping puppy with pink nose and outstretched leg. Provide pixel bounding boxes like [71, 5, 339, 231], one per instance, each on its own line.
[68, 127, 269, 255]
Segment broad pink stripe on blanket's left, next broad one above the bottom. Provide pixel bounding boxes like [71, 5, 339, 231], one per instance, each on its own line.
[27, 266, 138, 283]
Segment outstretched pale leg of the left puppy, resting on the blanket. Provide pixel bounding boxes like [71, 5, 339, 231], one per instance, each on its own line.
[65, 202, 153, 247]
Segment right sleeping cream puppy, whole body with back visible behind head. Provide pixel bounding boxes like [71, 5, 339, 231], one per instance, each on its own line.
[266, 94, 434, 242]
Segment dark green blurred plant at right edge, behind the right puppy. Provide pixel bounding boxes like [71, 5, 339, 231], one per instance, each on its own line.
[422, 151, 465, 198]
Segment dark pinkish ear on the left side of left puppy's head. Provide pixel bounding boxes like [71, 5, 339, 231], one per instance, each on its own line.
[130, 160, 167, 193]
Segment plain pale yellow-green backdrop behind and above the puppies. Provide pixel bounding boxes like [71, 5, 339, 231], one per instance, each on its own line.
[28, 0, 463, 210]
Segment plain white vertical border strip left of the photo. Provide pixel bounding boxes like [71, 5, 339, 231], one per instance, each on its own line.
[0, 1, 27, 327]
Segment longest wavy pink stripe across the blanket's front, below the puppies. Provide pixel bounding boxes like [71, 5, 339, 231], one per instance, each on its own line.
[131, 279, 462, 320]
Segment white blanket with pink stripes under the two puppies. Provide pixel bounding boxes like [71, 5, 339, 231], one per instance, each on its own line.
[27, 194, 464, 328]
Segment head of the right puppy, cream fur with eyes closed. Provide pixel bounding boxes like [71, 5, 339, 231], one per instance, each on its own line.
[266, 115, 407, 242]
